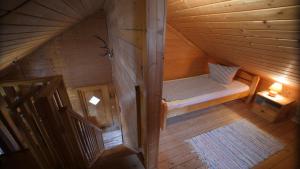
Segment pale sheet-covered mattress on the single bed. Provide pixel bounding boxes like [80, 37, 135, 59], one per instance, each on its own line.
[163, 74, 249, 110]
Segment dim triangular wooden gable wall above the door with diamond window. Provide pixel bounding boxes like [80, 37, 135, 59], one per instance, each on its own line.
[2, 11, 111, 88]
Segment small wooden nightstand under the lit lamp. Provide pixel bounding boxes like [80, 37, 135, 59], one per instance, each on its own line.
[252, 91, 294, 122]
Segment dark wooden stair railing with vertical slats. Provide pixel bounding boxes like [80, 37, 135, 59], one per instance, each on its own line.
[0, 76, 104, 169]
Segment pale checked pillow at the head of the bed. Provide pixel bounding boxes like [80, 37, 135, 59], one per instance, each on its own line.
[208, 63, 239, 84]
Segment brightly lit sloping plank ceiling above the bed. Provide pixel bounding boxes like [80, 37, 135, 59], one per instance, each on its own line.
[168, 0, 300, 85]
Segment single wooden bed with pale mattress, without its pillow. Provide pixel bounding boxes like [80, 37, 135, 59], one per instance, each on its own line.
[161, 70, 260, 129]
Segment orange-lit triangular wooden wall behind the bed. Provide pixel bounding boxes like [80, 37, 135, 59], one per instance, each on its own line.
[164, 25, 208, 80]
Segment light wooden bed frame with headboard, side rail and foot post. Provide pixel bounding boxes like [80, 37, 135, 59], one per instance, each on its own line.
[160, 70, 260, 129]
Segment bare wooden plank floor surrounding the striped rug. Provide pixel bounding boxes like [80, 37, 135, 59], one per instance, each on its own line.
[159, 101, 300, 169]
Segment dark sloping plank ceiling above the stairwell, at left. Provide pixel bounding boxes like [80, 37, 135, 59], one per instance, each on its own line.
[0, 0, 104, 70]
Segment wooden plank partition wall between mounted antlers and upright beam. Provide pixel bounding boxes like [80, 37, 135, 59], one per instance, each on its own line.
[104, 0, 145, 150]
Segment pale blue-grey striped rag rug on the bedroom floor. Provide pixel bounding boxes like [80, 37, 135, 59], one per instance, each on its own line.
[186, 120, 284, 169]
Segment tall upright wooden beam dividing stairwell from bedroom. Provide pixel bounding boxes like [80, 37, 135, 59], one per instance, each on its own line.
[144, 0, 166, 169]
